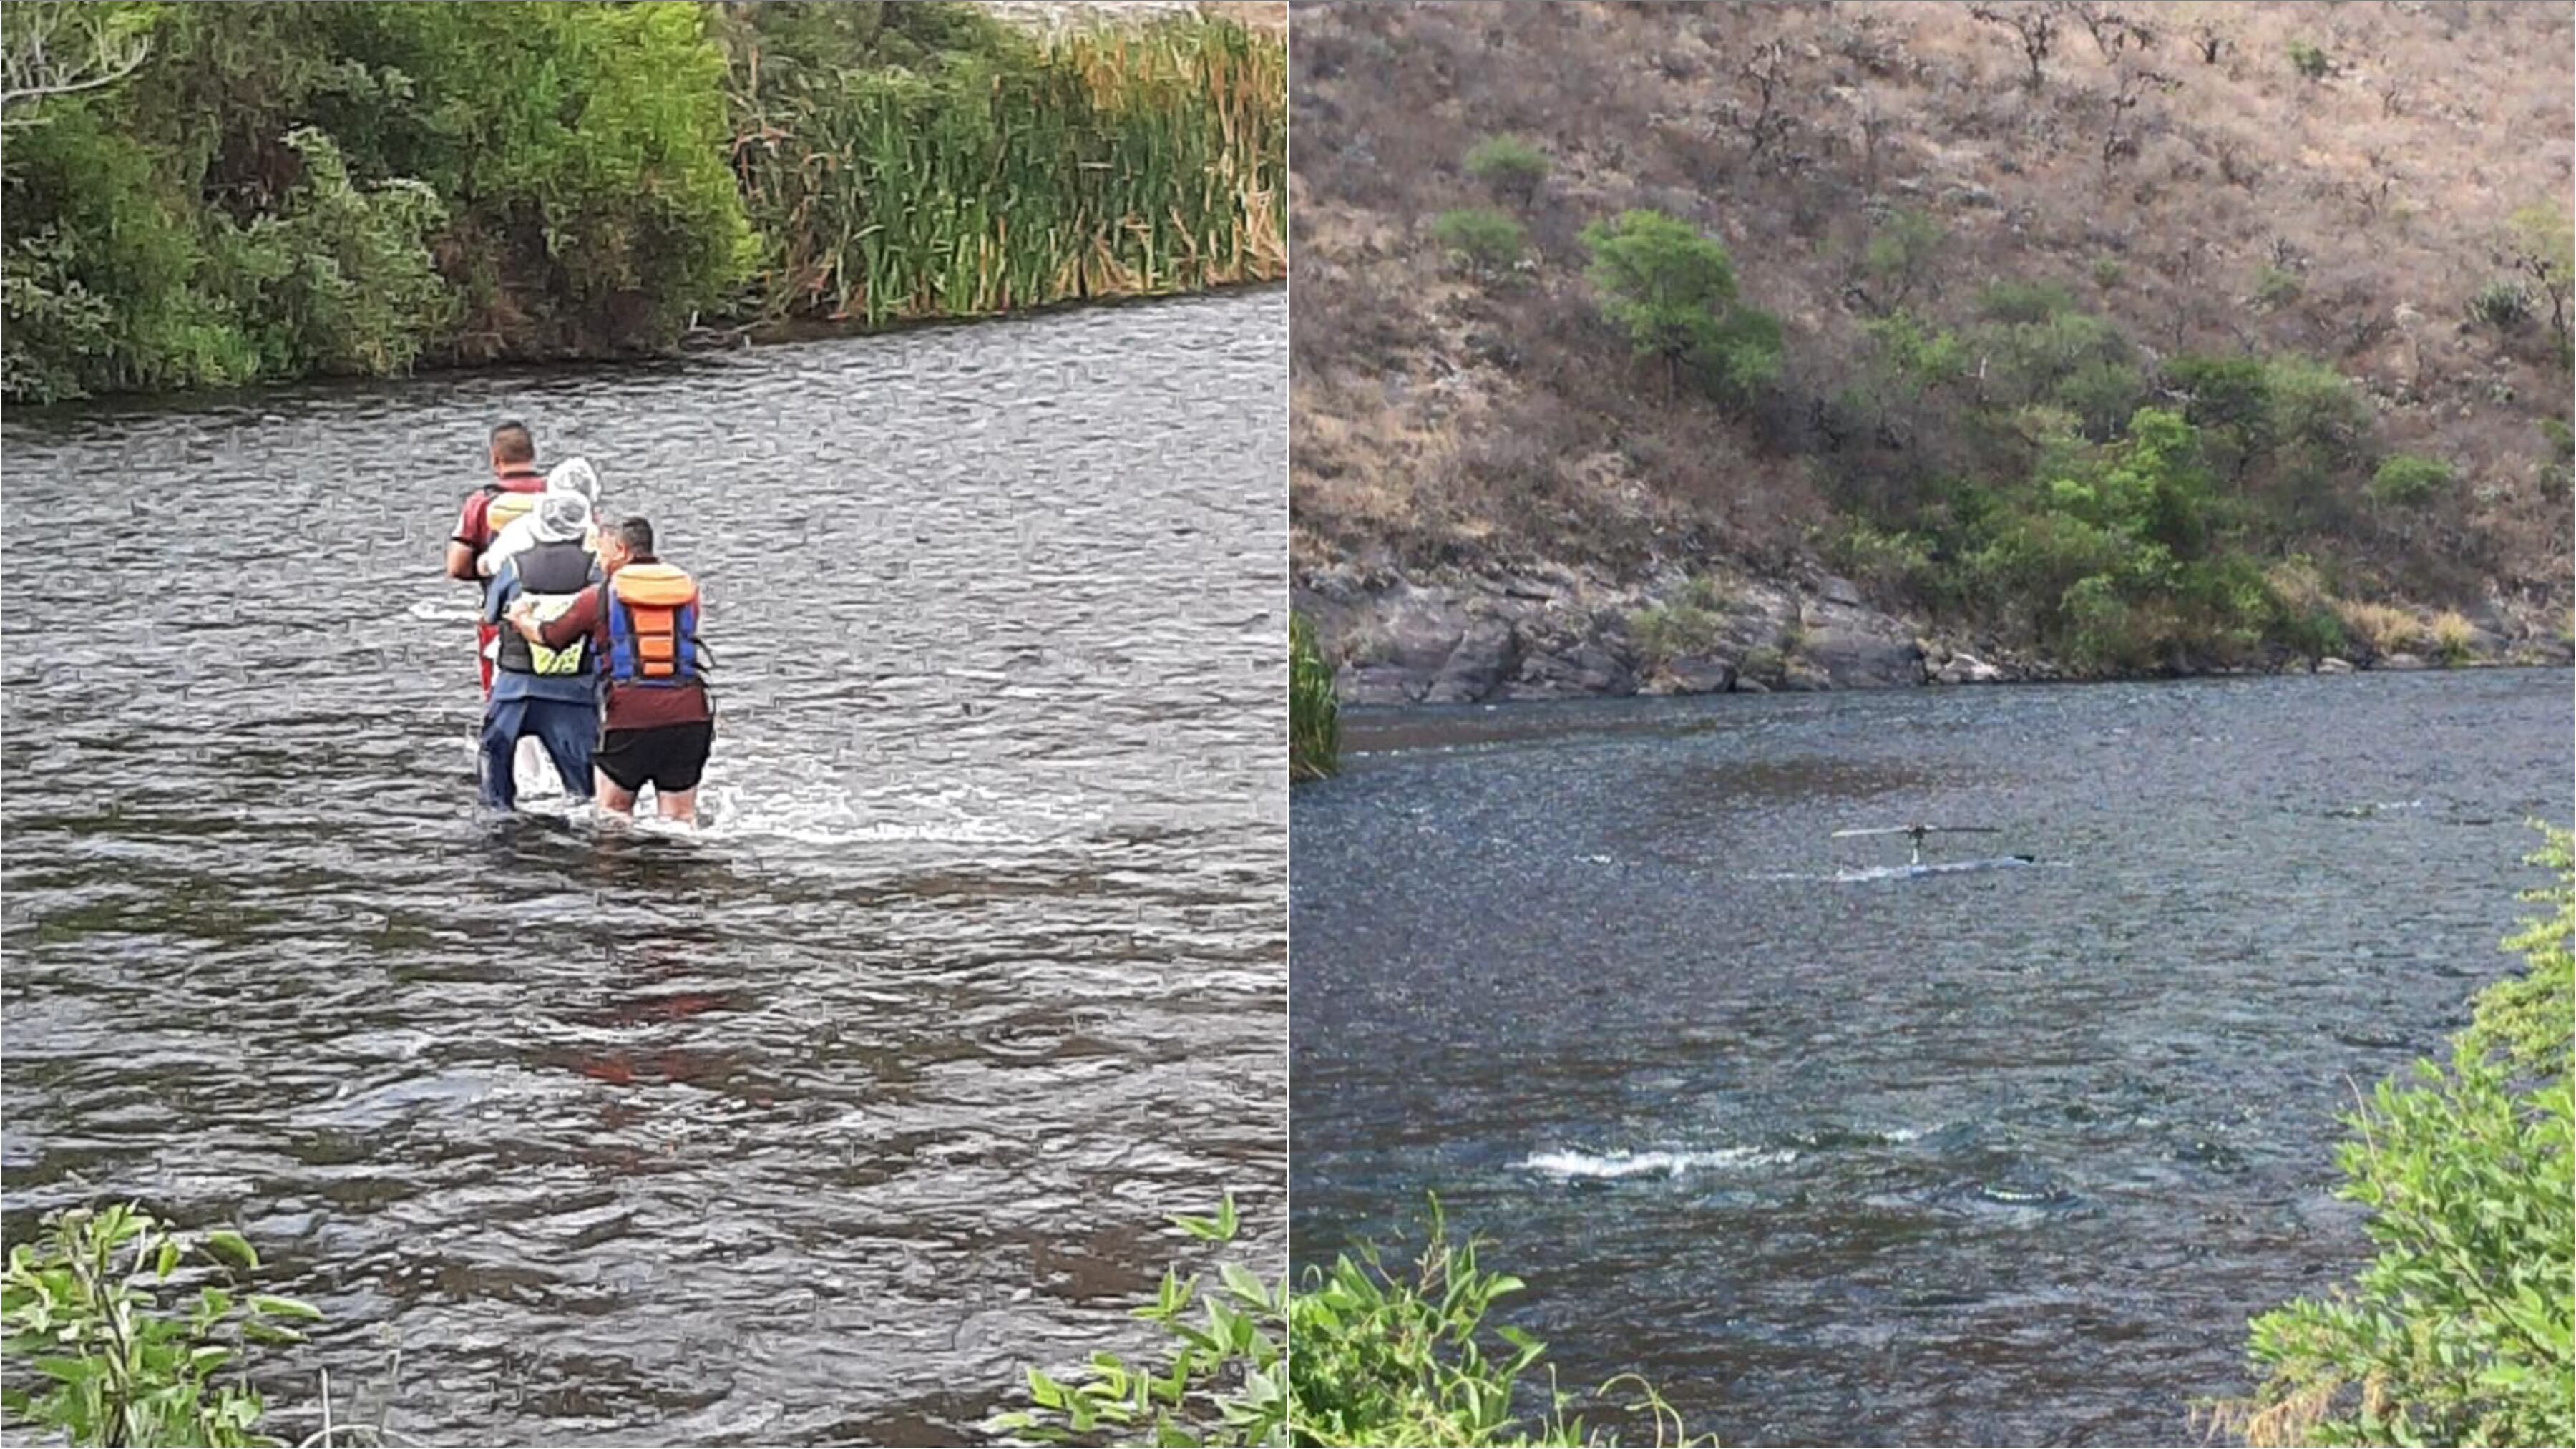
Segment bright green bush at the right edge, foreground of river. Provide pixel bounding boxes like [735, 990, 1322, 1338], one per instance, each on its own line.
[2220, 830, 2576, 1444]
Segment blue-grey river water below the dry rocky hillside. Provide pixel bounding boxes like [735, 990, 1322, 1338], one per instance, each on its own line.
[1291, 670, 2571, 1444]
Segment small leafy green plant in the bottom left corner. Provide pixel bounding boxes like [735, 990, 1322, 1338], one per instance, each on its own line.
[0, 1204, 322, 1446]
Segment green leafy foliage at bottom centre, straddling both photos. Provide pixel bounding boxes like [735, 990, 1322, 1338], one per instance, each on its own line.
[995, 1196, 1713, 1446]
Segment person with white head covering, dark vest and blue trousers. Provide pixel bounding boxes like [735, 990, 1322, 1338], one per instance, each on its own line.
[482, 492, 600, 809]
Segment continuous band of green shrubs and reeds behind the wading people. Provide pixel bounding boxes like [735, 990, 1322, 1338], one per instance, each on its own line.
[0, 3, 1285, 402]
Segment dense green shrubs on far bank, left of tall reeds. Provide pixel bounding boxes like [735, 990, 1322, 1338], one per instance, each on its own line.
[5, 3, 752, 399]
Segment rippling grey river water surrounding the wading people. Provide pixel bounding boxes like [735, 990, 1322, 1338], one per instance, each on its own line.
[0, 291, 1288, 1444]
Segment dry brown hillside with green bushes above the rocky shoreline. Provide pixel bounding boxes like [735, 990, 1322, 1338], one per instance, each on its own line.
[1291, 3, 2571, 673]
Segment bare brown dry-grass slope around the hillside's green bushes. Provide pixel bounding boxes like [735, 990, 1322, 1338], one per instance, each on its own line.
[1291, 3, 2576, 608]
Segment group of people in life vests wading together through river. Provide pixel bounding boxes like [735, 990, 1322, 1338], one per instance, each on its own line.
[448, 423, 716, 822]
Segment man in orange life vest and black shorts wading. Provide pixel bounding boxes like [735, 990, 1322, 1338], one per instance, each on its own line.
[507, 518, 716, 822]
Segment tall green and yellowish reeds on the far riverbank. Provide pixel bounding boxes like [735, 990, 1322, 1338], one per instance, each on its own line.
[734, 21, 1288, 325]
